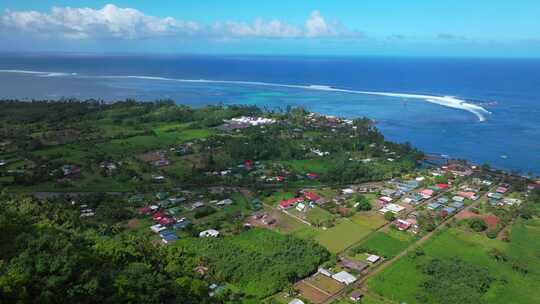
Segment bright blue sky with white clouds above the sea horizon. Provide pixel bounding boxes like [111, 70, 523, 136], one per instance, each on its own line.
[0, 0, 540, 57]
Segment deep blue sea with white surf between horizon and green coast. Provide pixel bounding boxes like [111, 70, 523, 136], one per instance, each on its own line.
[0, 54, 540, 174]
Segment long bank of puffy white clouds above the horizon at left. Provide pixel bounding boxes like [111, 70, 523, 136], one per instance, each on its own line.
[0, 4, 359, 39]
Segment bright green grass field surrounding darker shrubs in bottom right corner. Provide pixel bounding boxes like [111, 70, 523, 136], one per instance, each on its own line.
[368, 220, 540, 304]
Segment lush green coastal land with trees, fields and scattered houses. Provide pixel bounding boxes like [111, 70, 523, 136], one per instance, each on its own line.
[0, 99, 540, 304]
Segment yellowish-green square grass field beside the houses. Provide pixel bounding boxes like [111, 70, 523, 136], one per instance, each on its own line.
[315, 219, 371, 253]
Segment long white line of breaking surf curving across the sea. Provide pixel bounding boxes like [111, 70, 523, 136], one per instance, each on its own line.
[0, 70, 491, 122]
